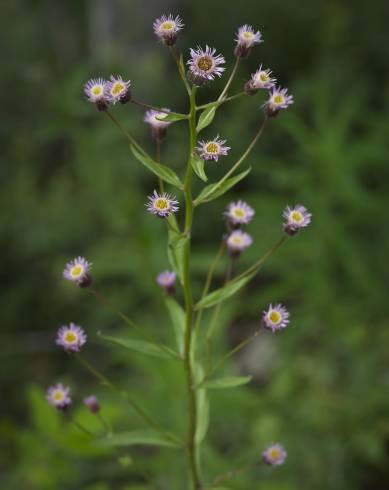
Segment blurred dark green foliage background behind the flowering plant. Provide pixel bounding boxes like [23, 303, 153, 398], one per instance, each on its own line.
[0, 0, 389, 490]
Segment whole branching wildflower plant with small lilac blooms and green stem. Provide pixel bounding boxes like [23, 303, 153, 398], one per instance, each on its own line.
[47, 14, 311, 490]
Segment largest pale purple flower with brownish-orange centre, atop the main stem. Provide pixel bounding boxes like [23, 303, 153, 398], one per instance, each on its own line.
[187, 46, 226, 86]
